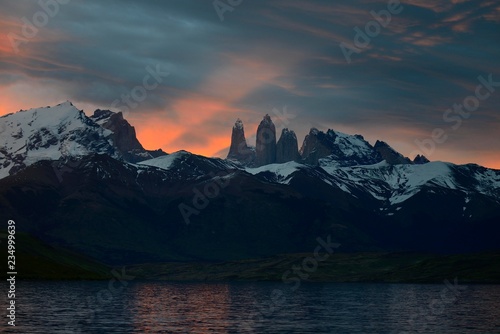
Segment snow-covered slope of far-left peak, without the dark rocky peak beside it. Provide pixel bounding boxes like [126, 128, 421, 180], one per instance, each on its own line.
[0, 102, 115, 178]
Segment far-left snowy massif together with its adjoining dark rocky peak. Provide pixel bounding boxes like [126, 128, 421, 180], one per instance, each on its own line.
[0, 101, 165, 178]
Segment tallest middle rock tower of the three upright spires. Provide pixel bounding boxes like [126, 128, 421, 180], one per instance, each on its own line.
[255, 115, 276, 167]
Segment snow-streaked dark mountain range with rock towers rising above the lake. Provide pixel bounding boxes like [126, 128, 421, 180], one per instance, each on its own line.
[0, 102, 500, 264]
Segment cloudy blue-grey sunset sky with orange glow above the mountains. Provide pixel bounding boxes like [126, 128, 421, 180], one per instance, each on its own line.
[0, 0, 500, 169]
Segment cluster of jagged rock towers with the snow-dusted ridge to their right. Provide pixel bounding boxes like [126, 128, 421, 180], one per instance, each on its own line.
[228, 114, 414, 167]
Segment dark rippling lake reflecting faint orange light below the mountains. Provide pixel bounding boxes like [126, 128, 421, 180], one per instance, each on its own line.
[1, 280, 500, 334]
